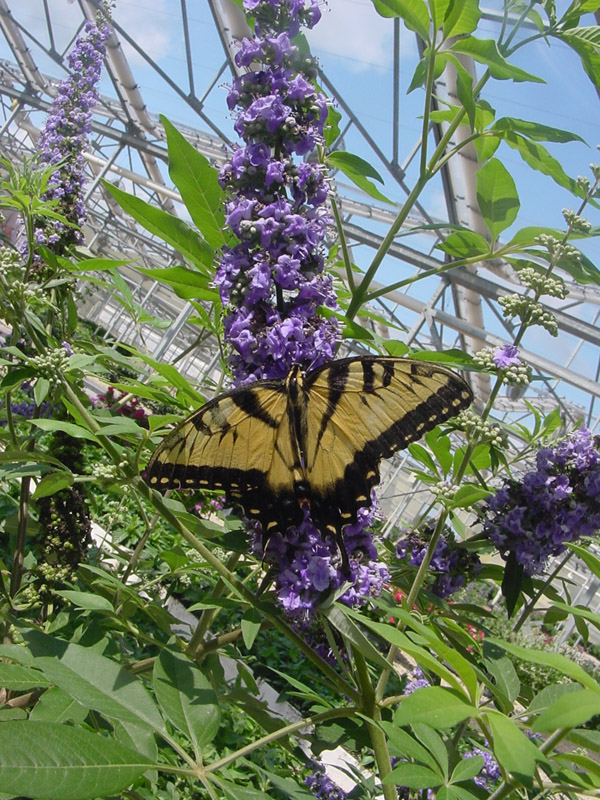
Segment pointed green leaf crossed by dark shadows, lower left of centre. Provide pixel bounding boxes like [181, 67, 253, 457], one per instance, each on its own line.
[152, 648, 221, 757]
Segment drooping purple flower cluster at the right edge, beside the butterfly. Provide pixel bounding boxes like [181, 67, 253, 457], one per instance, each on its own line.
[483, 428, 600, 576]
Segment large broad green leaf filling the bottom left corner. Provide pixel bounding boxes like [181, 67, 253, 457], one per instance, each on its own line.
[0, 722, 152, 800]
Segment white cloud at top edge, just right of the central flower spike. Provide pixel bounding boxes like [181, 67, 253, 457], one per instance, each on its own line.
[307, 0, 406, 72]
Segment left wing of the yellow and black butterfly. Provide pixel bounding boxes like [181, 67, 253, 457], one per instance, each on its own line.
[146, 381, 302, 535]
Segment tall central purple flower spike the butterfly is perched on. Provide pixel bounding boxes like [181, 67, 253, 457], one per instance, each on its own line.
[221, 0, 387, 622]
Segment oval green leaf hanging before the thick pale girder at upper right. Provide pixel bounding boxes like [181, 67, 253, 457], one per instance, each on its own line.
[477, 158, 520, 241]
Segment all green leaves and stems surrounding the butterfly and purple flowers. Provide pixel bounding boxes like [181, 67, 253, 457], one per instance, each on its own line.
[0, 0, 600, 800]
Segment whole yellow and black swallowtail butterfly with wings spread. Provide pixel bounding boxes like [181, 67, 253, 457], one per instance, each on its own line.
[146, 356, 473, 560]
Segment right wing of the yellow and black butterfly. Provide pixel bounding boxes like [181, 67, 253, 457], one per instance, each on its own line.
[305, 356, 473, 532]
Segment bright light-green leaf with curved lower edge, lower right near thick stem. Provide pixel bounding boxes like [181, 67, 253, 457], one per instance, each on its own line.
[394, 686, 478, 730]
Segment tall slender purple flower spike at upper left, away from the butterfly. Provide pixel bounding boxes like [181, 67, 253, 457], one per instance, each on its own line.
[36, 21, 110, 247]
